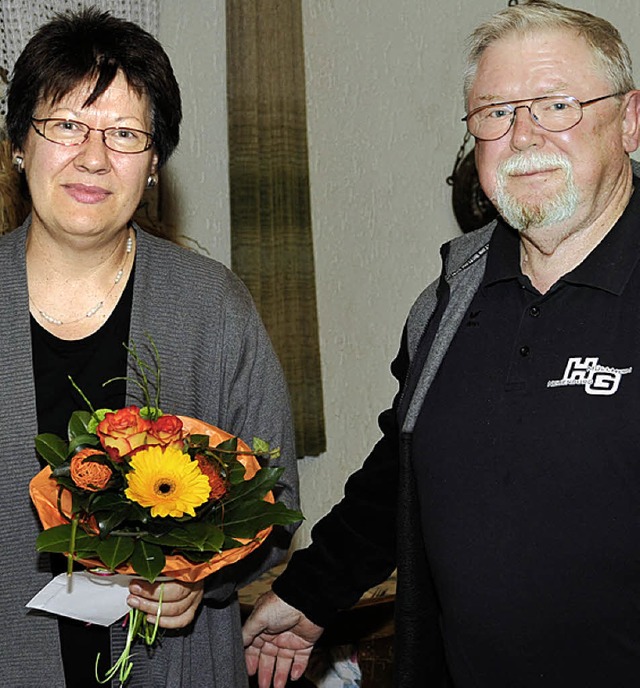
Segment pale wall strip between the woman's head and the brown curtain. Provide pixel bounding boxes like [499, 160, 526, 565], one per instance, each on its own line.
[159, 0, 230, 265]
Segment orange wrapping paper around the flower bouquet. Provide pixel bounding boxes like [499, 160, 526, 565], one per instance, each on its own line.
[29, 416, 274, 583]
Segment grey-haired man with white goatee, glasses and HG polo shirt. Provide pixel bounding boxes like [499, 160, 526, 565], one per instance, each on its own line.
[245, 0, 640, 688]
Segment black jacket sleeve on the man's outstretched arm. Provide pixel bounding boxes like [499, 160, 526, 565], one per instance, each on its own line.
[273, 334, 409, 626]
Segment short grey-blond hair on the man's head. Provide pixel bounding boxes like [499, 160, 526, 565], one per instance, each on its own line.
[464, 0, 635, 104]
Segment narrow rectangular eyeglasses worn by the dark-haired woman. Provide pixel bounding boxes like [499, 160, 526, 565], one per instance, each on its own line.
[31, 117, 153, 153]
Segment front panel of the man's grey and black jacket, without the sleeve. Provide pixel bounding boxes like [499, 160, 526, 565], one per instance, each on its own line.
[394, 222, 495, 688]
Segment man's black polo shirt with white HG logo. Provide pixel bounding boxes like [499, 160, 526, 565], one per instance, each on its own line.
[414, 184, 640, 688]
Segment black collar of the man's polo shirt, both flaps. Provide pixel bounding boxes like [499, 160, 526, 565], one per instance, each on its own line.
[482, 177, 640, 296]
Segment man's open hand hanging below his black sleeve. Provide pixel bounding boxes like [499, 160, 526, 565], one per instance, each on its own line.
[242, 591, 324, 688]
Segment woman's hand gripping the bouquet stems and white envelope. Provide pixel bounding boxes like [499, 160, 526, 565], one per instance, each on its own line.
[127, 578, 204, 628]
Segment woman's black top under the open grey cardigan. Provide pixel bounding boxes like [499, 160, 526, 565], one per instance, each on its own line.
[31, 278, 133, 688]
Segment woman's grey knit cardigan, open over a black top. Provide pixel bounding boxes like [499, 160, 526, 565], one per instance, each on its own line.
[0, 221, 298, 688]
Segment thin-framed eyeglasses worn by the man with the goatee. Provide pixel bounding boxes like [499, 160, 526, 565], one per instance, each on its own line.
[462, 93, 624, 141]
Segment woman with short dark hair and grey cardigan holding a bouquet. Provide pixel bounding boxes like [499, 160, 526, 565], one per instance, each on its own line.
[0, 10, 297, 688]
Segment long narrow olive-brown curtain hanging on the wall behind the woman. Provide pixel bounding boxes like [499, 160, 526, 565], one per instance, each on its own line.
[226, 0, 326, 456]
